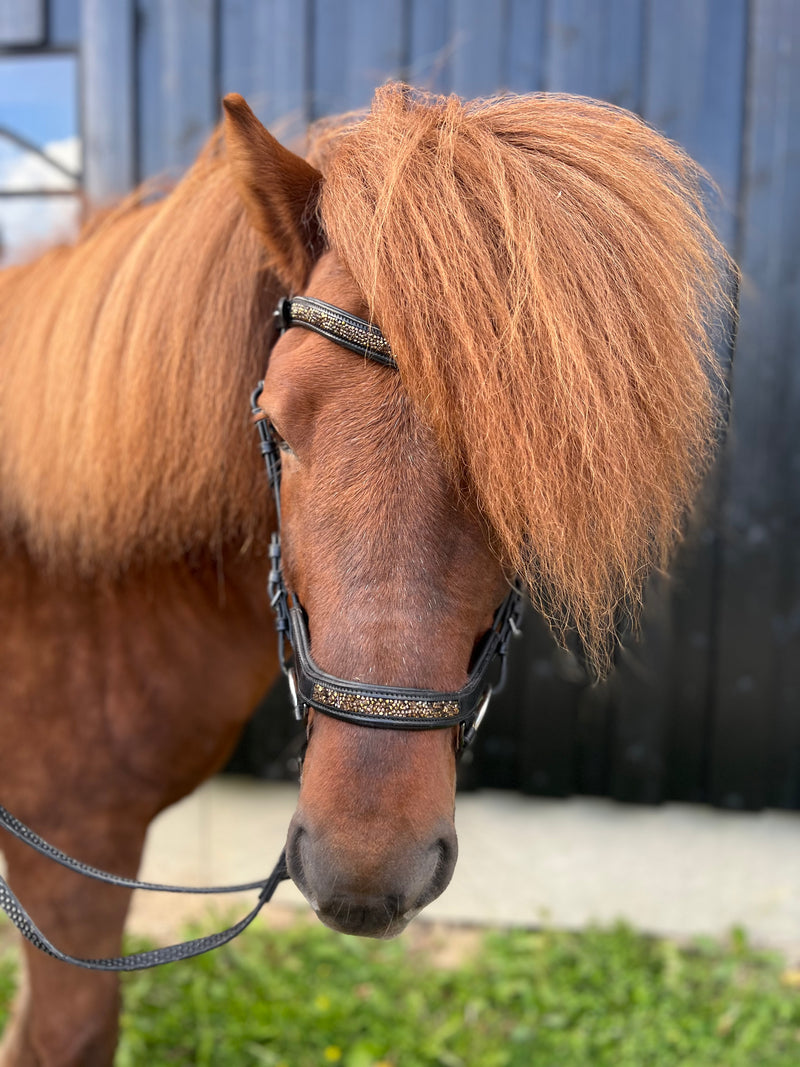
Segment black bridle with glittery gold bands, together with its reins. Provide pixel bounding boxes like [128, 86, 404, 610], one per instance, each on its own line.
[0, 297, 522, 971]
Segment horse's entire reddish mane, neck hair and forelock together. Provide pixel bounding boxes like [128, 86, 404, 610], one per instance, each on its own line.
[0, 85, 727, 669]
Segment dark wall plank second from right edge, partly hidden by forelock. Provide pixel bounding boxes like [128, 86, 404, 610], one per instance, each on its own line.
[611, 0, 747, 802]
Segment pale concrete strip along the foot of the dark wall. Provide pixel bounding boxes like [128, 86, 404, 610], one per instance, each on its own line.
[132, 778, 800, 960]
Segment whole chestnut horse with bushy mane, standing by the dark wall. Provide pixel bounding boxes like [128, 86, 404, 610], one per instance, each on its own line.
[0, 84, 730, 1067]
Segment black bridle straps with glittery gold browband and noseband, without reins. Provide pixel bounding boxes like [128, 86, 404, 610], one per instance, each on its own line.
[251, 297, 522, 749]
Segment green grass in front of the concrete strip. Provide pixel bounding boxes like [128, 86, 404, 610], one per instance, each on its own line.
[0, 923, 800, 1067]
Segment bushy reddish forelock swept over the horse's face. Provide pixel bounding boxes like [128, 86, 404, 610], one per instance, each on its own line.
[310, 85, 731, 672]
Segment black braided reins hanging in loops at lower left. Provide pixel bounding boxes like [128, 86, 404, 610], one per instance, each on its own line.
[0, 806, 289, 971]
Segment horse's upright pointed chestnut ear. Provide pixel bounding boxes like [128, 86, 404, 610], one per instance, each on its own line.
[222, 93, 324, 290]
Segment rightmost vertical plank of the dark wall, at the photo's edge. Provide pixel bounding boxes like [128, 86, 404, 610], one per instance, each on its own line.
[710, 0, 800, 808]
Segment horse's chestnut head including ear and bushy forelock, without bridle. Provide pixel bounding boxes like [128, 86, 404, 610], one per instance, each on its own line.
[225, 87, 733, 936]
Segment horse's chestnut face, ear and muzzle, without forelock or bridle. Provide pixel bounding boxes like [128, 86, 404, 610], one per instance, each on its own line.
[226, 98, 508, 936]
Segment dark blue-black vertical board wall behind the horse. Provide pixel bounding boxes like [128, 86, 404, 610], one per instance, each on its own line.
[78, 0, 800, 808]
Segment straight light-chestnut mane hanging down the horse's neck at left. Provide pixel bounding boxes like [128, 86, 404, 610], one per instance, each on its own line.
[0, 136, 276, 573]
